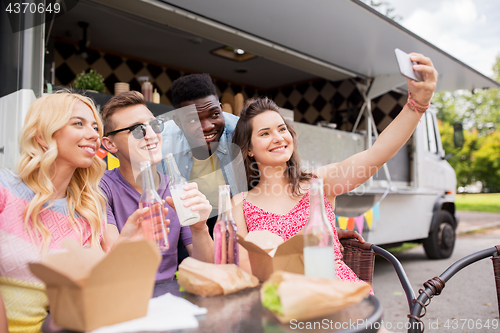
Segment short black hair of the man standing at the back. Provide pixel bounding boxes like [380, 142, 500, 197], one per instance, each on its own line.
[170, 74, 218, 108]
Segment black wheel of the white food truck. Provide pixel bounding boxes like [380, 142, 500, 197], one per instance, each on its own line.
[423, 210, 456, 259]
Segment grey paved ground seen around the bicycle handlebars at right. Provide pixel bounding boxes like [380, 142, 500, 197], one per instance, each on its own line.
[373, 212, 500, 333]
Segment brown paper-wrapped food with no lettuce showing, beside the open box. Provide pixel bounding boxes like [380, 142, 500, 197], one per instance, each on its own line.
[177, 257, 259, 296]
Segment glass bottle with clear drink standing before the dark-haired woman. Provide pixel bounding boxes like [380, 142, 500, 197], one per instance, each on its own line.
[304, 178, 336, 279]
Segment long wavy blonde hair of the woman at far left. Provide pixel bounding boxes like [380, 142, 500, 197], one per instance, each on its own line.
[16, 91, 106, 247]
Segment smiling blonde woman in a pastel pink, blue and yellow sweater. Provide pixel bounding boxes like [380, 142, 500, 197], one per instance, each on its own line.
[0, 92, 156, 333]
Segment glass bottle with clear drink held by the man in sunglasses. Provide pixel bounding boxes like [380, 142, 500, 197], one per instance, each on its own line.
[166, 153, 200, 226]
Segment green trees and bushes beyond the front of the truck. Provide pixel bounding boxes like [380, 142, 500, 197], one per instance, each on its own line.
[433, 56, 500, 191]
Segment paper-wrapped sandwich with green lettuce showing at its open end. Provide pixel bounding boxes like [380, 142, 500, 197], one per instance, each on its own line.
[260, 271, 370, 323]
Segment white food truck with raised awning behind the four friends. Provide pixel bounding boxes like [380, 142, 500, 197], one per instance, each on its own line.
[0, 0, 499, 258]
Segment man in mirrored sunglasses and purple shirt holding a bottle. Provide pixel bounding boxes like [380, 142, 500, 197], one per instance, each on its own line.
[100, 91, 213, 281]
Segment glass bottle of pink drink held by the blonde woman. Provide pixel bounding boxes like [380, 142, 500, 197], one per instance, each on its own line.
[139, 161, 169, 251]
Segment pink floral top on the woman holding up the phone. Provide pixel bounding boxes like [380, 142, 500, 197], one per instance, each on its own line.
[243, 190, 373, 286]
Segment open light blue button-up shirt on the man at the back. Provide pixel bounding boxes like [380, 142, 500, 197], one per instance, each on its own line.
[162, 112, 247, 196]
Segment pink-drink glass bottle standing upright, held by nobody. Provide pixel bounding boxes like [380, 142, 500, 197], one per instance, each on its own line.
[214, 185, 240, 265]
